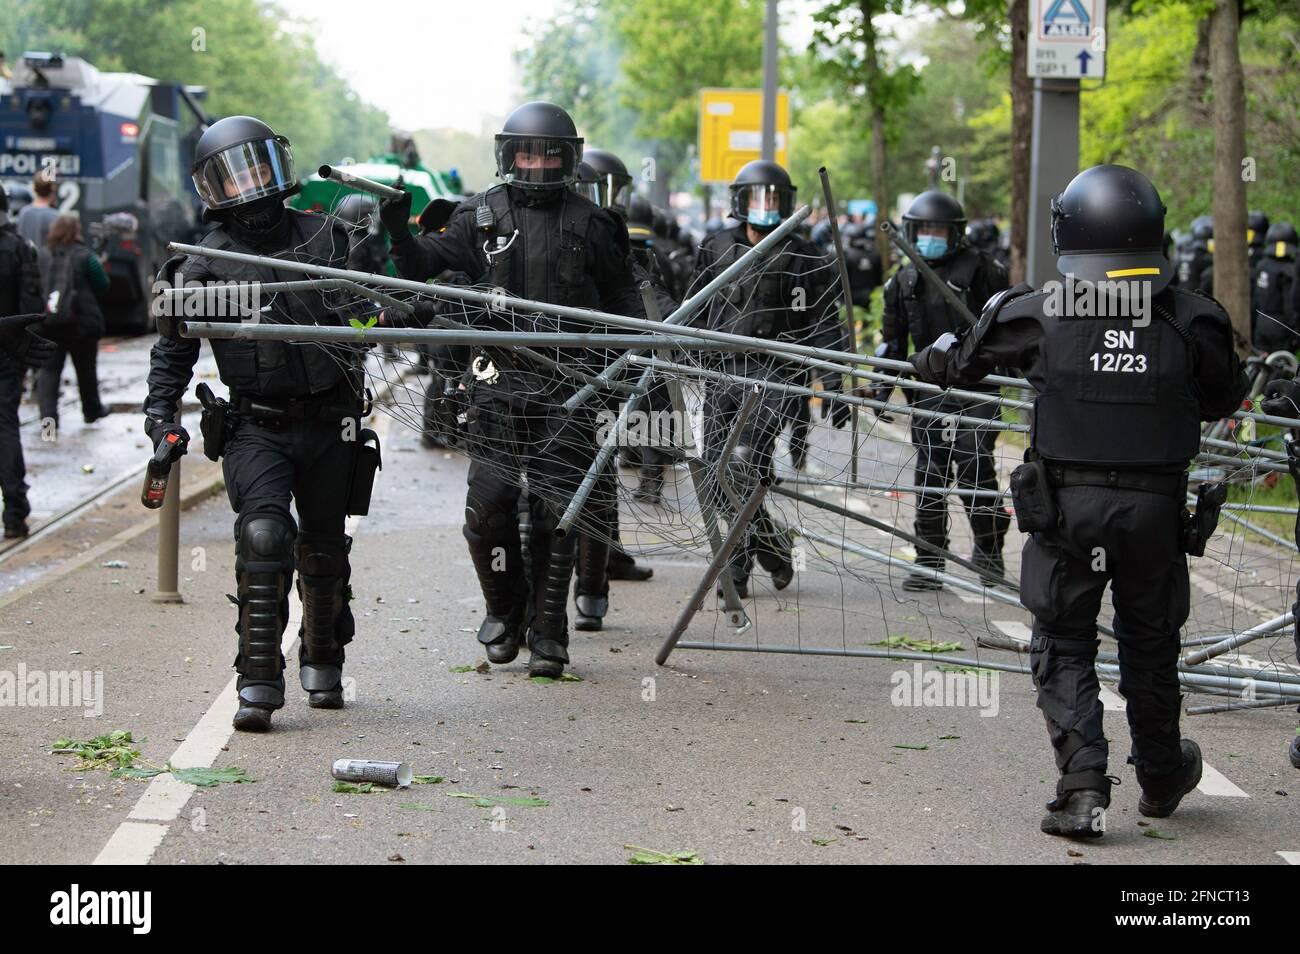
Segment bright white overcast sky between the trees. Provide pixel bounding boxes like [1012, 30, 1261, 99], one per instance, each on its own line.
[280, 0, 811, 133]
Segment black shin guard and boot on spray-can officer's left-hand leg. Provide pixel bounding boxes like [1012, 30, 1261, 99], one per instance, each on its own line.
[230, 513, 294, 732]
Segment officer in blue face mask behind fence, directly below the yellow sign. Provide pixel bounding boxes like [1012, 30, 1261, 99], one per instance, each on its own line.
[692, 159, 849, 595]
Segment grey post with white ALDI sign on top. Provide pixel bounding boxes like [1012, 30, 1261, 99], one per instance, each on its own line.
[1026, 0, 1106, 287]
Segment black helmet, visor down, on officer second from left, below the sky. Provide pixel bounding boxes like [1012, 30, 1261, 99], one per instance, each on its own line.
[495, 100, 594, 188]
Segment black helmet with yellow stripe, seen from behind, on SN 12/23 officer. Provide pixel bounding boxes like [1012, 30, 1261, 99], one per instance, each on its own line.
[1052, 165, 1174, 294]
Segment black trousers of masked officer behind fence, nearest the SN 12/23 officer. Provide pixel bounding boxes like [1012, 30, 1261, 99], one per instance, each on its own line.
[911, 393, 1011, 567]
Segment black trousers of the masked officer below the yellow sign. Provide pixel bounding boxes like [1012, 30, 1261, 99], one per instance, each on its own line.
[703, 383, 790, 582]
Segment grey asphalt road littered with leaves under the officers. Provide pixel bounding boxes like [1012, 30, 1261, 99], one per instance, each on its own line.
[0, 358, 1300, 864]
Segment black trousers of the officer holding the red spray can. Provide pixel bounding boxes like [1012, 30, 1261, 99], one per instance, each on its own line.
[222, 417, 360, 681]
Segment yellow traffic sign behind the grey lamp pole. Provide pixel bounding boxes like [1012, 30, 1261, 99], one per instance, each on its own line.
[699, 90, 790, 182]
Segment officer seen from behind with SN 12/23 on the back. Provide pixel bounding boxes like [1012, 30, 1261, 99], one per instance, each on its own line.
[911, 165, 1248, 837]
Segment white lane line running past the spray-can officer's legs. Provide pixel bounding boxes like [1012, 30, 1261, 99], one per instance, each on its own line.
[92, 415, 391, 864]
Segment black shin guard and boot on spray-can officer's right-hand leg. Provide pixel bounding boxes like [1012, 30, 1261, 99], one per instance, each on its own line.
[296, 532, 355, 708]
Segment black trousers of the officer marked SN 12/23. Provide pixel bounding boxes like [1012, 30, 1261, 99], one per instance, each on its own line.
[1021, 486, 1190, 793]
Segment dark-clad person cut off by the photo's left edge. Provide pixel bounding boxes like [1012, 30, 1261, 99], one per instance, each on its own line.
[0, 188, 51, 539]
